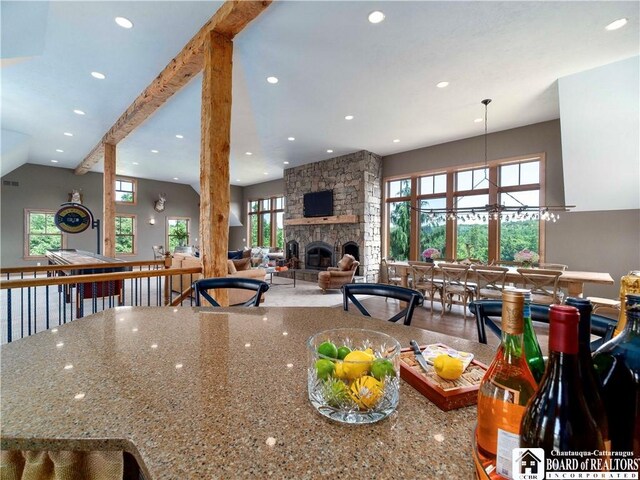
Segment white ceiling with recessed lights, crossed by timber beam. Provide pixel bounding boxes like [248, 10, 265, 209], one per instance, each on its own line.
[0, 1, 640, 189]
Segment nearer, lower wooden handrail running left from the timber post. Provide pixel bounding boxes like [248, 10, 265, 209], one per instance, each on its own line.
[0, 267, 202, 290]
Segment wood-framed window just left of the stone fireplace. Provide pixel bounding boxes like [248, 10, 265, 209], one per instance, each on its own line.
[248, 197, 284, 248]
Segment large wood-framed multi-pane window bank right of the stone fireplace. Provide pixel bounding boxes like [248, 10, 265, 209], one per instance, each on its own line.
[384, 155, 544, 262]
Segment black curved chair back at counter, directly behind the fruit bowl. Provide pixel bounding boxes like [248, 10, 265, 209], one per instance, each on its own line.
[342, 283, 424, 325]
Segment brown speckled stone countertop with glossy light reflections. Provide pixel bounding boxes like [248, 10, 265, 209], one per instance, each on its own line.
[1, 307, 493, 480]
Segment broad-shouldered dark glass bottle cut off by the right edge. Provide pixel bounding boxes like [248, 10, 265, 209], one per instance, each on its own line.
[593, 295, 640, 457]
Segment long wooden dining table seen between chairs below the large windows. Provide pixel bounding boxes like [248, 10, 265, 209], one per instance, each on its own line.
[387, 261, 614, 298]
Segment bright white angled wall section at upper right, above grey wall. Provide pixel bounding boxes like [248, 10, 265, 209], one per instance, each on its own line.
[558, 56, 640, 212]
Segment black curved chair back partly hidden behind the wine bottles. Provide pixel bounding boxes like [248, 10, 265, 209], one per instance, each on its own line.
[469, 300, 617, 352]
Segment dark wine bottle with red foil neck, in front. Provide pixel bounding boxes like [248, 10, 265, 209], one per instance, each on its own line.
[520, 305, 604, 462]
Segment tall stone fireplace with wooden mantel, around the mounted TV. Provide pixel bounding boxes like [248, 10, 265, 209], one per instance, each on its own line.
[284, 150, 382, 282]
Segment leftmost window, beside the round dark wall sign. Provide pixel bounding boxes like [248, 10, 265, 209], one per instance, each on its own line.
[24, 210, 64, 258]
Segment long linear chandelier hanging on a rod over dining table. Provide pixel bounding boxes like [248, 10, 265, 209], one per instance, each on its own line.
[412, 98, 575, 222]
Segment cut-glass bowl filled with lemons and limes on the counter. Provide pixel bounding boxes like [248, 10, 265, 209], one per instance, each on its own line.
[307, 328, 401, 424]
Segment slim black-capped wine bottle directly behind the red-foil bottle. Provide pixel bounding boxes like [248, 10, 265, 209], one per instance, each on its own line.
[565, 297, 611, 450]
